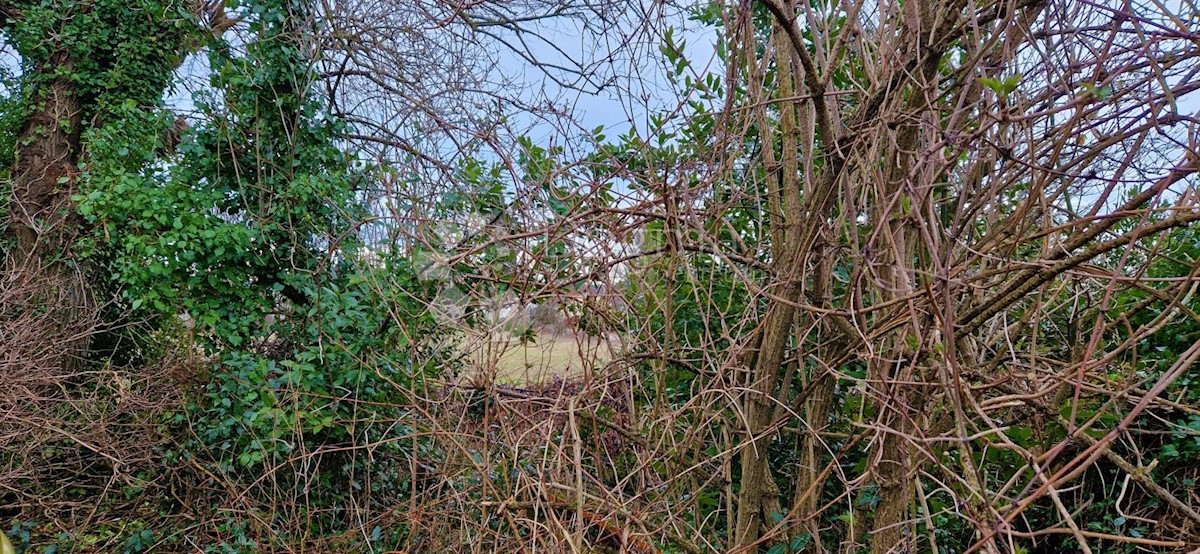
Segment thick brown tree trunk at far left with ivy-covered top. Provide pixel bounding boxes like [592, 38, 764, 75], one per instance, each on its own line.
[0, 0, 194, 367]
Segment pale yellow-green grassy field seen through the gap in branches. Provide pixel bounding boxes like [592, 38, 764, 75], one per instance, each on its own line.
[464, 333, 612, 385]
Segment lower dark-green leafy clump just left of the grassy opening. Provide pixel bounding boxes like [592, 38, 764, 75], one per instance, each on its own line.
[180, 261, 445, 471]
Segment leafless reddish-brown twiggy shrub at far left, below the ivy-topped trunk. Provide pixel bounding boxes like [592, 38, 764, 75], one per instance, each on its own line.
[0, 272, 198, 548]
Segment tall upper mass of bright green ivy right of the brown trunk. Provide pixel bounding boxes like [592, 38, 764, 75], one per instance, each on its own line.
[77, 0, 355, 349]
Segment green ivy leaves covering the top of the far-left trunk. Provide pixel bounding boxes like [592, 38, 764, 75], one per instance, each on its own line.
[0, 0, 197, 255]
